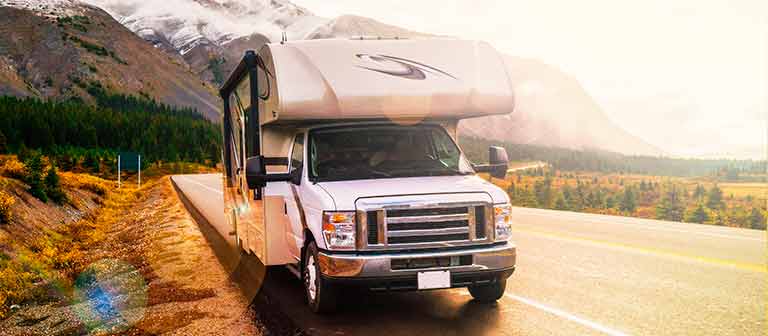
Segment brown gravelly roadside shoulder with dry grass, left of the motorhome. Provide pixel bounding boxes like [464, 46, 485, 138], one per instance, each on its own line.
[0, 178, 262, 335]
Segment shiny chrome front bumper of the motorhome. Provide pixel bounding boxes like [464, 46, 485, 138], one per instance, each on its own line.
[318, 241, 516, 290]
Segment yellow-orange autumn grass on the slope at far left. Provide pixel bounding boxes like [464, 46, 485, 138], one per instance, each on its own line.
[0, 173, 149, 318]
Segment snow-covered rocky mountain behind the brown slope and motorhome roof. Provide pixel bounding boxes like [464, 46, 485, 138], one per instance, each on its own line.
[86, 0, 329, 85]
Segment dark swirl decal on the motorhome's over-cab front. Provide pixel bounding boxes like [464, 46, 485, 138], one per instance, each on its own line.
[355, 54, 458, 80]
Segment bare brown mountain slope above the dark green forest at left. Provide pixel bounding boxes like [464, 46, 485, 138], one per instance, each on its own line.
[0, 0, 219, 120]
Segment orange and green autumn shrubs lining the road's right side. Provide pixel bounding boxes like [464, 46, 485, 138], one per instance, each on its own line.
[507, 172, 768, 230]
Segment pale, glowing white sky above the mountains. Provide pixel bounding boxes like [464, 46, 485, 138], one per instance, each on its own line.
[292, 0, 768, 158]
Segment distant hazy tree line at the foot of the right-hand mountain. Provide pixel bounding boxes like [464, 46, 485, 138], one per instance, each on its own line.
[459, 137, 766, 182]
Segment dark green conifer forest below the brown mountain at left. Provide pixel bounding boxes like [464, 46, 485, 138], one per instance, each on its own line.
[0, 92, 222, 170]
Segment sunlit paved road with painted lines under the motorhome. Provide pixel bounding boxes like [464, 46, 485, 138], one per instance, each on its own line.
[174, 175, 768, 336]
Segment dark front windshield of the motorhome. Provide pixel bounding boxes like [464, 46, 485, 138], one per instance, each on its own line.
[309, 125, 474, 181]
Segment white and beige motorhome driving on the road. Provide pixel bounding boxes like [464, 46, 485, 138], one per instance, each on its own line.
[221, 39, 516, 312]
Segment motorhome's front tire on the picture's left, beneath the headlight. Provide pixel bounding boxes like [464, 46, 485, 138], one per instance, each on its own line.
[301, 242, 337, 313]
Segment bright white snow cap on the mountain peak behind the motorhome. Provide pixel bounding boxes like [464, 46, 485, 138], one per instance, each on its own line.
[83, 0, 329, 55]
